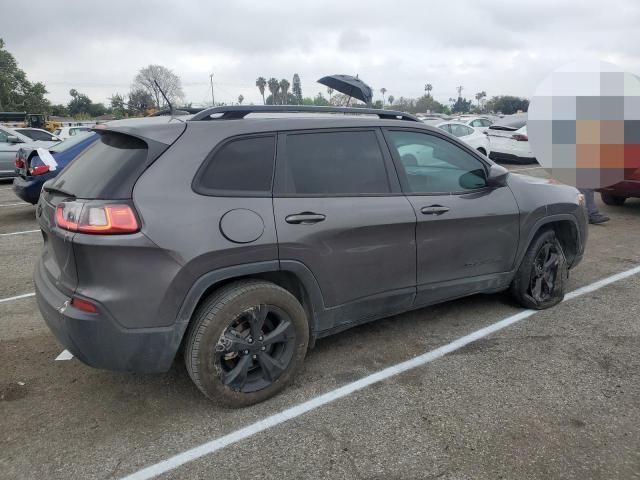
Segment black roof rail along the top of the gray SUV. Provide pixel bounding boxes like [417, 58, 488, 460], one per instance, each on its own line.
[189, 105, 420, 122]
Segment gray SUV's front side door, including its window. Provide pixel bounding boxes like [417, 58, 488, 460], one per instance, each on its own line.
[385, 129, 519, 305]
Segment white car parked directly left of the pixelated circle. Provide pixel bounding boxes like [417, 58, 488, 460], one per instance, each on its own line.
[486, 114, 536, 164]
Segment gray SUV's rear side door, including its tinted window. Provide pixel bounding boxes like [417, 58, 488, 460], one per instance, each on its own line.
[273, 128, 416, 323]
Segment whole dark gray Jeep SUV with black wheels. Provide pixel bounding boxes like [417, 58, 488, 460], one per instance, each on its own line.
[34, 106, 587, 406]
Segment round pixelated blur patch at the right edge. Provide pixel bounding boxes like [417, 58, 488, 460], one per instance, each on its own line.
[527, 61, 640, 188]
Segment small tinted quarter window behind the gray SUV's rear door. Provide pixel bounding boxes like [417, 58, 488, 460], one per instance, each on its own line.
[196, 135, 275, 195]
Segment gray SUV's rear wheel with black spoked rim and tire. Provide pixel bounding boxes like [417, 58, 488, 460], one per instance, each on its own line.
[184, 280, 309, 408]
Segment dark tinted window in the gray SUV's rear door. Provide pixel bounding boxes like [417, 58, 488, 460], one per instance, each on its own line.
[278, 131, 390, 196]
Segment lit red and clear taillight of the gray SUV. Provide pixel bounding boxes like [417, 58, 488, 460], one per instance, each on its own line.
[56, 202, 140, 235]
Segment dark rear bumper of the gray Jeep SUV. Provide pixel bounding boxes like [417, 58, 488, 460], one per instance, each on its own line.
[34, 261, 184, 373]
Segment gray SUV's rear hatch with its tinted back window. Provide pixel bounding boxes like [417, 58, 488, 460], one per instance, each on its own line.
[36, 123, 186, 296]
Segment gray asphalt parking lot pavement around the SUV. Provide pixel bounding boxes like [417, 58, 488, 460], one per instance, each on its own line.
[0, 178, 640, 479]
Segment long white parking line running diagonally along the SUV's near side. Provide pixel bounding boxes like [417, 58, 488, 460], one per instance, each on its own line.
[121, 266, 640, 480]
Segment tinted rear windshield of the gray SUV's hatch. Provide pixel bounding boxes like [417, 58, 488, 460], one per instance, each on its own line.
[51, 132, 148, 199]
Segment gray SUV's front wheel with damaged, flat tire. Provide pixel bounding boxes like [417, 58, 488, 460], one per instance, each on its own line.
[511, 229, 567, 310]
